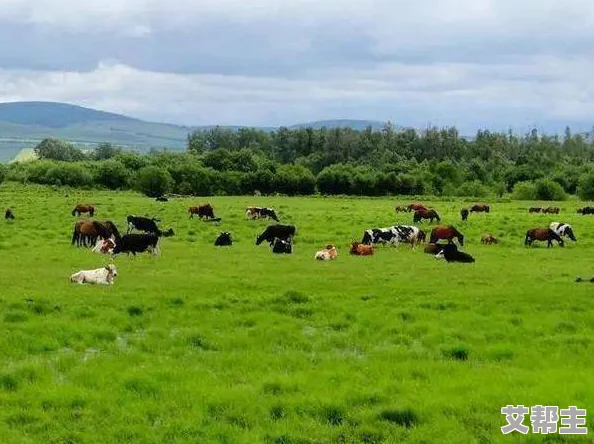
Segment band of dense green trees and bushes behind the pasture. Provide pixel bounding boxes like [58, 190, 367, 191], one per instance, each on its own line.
[0, 123, 594, 200]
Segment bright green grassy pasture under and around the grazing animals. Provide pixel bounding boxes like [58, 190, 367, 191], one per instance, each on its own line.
[0, 184, 594, 444]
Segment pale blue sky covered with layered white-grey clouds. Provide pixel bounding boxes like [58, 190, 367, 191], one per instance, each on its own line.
[0, 0, 594, 133]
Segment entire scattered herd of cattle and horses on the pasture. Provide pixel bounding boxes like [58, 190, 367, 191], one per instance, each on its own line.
[5, 197, 594, 284]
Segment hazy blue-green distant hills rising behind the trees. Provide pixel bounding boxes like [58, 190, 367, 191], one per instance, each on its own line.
[0, 102, 394, 161]
